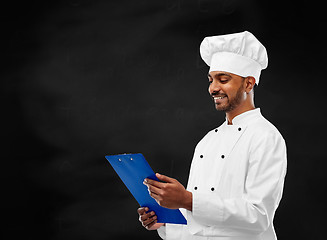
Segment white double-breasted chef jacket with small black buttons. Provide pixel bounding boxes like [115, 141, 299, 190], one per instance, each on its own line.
[158, 108, 287, 240]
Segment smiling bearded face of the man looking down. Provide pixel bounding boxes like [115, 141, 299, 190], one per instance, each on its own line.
[208, 71, 246, 112]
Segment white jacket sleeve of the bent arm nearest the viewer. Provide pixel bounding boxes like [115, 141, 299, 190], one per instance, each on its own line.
[191, 129, 286, 235]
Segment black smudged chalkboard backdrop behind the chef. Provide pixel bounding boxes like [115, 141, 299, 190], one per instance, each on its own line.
[0, 0, 327, 240]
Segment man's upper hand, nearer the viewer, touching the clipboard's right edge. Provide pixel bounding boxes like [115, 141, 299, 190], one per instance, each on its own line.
[143, 173, 192, 211]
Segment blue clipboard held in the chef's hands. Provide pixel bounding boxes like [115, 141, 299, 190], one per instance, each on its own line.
[105, 153, 187, 224]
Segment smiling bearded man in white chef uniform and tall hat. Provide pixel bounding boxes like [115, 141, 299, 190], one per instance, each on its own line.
[138, 31, 286, 240]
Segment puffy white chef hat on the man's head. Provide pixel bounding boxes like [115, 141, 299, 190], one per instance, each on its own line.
[200, 31, 268, 84]
